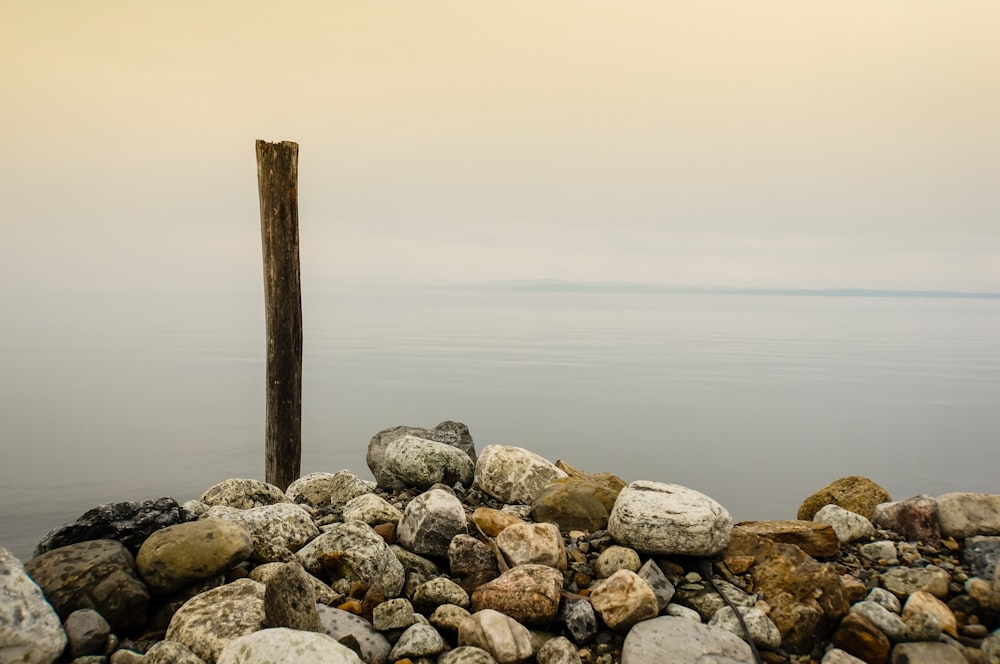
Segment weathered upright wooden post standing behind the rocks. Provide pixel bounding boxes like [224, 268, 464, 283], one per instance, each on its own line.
[257, 141, 302, 490]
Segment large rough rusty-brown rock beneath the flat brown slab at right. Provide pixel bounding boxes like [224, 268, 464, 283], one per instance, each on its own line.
[751, 538, 850, 653]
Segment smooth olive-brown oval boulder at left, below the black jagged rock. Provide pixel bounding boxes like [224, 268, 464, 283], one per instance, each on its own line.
[135, 519, 253, 595]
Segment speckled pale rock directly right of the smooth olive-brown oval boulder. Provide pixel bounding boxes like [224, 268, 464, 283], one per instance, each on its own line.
[202, 503, 319, 563]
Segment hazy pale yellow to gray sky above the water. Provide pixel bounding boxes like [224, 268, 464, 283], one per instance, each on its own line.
[0, 0, 1000, 291]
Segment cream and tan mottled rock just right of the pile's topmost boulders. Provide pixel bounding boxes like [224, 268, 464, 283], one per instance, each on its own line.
[475, 445, 567, 505]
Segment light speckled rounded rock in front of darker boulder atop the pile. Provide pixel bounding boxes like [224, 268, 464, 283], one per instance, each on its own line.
[383, 436, 475, 489]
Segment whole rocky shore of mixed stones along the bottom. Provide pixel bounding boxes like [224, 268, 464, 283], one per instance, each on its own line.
[0, 422, 1000, 664]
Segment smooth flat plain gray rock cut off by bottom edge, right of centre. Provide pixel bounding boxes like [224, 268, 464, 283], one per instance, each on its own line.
[622, 616, 754, 664]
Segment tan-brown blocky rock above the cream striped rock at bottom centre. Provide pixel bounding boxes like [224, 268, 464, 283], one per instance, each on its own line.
[469, 565, 563, 624]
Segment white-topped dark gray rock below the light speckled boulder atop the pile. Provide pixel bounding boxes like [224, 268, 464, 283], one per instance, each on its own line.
[396, 489, 468, 558]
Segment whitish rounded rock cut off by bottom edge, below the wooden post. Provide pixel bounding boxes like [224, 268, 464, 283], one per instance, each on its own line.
[217, 627, 364, 664]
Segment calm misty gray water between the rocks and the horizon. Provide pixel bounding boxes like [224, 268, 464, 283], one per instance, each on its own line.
[0, 288, 1000, 559]
